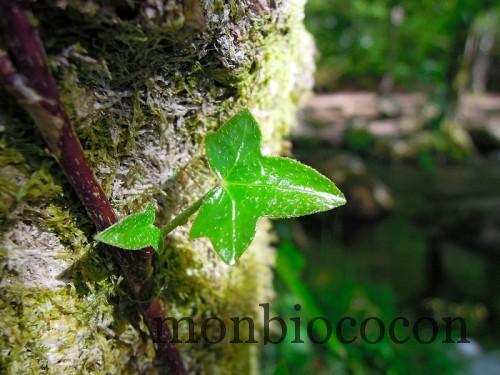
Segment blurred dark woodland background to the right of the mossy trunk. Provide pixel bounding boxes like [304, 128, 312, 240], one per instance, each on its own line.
[263, 0, 500, 375]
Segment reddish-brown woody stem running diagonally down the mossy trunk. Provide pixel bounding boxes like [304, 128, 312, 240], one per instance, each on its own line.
[0, 0, 187, 375]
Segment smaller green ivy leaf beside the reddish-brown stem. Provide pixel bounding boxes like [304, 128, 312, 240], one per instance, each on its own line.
[94, 204, 163, 251]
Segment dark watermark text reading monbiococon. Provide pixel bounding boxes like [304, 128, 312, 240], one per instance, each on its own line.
[152, 303, 470, 345]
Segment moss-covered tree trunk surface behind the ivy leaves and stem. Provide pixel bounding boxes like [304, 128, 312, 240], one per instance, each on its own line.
[0, 0, 313, 374]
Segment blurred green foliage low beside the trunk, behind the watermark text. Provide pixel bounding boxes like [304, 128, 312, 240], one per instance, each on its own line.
[265, 241, 463, 375]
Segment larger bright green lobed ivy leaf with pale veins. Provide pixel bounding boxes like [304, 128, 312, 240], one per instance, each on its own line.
[191, 110, 346, 264]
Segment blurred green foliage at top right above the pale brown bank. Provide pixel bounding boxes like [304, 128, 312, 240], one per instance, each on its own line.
[306, 0, 497, 91]
